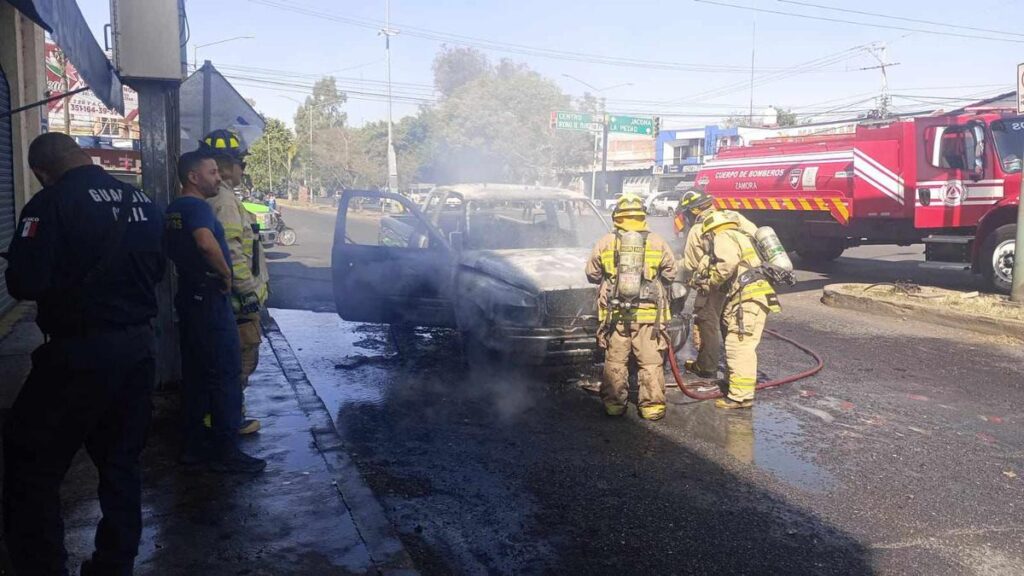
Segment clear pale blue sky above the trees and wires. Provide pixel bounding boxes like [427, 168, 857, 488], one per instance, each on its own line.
[78, 0, 1024, 126]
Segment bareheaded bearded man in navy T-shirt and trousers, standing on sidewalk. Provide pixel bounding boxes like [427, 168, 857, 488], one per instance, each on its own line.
[166, 151, 266, 472]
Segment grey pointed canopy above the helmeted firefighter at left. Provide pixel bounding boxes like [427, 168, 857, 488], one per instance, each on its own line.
[178, 61, 266, 153]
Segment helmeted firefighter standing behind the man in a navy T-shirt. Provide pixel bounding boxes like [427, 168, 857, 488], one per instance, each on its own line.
[203, 130, 268, 435]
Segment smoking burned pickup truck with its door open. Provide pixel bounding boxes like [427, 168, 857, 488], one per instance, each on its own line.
[332, 184, 608, 365]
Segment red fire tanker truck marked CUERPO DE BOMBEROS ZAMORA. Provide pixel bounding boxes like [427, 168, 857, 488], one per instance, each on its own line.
[696, 111, 1024, 292]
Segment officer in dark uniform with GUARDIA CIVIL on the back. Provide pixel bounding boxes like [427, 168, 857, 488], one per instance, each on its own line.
[3, 132, 164, 575]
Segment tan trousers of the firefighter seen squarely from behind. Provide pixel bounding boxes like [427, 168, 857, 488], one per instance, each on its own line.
[601, 323, 669, 407]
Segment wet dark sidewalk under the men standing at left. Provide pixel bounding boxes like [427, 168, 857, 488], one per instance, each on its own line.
[0, 308, 416, 575]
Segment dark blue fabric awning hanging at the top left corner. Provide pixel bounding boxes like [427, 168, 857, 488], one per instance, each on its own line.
[7, 0, 125, 116]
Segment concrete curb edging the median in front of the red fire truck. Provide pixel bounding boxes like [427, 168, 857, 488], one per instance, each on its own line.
[821, 284, 1024, 341]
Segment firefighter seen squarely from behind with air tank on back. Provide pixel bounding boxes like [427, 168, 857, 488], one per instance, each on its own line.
[587, 194, 676, 420]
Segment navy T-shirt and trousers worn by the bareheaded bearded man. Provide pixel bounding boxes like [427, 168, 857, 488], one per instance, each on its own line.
[165, 196, 242, 454]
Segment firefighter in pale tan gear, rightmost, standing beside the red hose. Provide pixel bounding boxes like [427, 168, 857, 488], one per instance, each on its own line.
[693, 211, 780, 409]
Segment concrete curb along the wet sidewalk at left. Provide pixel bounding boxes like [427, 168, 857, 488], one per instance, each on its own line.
[263, 318, 419, 576]
